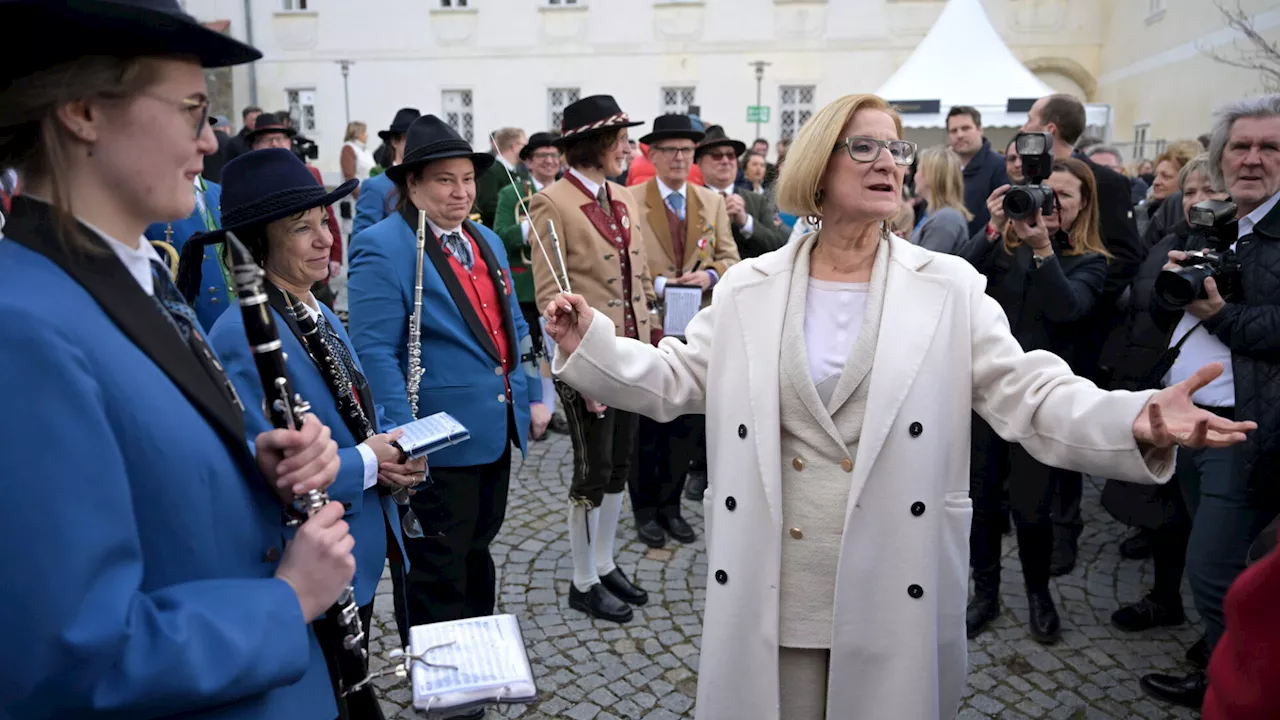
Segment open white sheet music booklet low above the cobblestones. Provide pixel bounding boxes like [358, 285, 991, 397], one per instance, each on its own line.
[408, 615, 538, 715]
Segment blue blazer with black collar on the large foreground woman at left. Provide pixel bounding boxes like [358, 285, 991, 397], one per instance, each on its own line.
[0, 199, 337, 720]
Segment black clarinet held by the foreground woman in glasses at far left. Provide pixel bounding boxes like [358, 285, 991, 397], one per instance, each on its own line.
[227, 232, 372, 698]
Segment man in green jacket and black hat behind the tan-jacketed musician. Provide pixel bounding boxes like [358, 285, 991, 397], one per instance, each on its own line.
[489, 132, 568, 433]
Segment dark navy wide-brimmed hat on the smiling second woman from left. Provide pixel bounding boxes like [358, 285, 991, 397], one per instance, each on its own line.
[177, 147, 360, 301]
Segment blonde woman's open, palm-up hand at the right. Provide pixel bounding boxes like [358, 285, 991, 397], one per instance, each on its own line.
[1133, 363, 1258, 448]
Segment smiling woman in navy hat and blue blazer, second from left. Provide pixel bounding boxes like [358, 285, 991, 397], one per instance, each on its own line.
[194, 149, 426, 719]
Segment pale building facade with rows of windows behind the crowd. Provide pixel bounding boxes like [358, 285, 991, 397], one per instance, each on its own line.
[186, 0, 1280, 179]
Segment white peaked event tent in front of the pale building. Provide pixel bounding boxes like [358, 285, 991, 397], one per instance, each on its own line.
[876, 0, 1111, 139]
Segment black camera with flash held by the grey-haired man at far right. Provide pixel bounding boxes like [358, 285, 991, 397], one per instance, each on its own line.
[1156, 200, 1240, 310]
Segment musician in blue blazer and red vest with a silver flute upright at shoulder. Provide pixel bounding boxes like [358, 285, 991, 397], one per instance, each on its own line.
[348, 115, 549, 638]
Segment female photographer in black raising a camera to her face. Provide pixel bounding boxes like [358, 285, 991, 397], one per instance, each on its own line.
[960, 149, 1107, 644]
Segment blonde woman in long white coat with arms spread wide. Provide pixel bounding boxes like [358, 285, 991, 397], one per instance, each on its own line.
[545, 95, 1252, 720]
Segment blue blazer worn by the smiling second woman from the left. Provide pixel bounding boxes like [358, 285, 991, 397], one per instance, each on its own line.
[209, 293, 403, 606]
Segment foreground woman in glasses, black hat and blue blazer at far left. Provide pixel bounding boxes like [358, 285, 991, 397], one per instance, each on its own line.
[0, 0, 355, 720]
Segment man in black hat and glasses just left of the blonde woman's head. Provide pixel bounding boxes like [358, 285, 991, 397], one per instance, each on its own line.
[694, 126, 788, 260]
